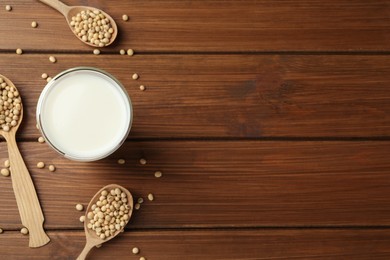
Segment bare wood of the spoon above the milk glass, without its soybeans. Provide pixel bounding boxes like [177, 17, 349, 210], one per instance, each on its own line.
[39, 0, 118, 47]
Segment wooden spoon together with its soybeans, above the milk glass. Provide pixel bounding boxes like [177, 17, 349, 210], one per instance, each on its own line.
[39, 0, 118, 47]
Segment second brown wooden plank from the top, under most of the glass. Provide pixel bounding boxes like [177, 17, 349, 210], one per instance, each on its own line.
[0, 54, 390, 139]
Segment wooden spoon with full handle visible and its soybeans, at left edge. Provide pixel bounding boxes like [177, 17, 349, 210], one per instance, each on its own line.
[0, 75, 50, 247]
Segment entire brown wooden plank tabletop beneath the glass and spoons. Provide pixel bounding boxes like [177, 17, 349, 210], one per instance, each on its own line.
[0, 0, 390, 259]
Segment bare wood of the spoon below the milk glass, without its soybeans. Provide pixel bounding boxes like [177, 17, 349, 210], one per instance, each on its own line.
[77, 184, 133, 260]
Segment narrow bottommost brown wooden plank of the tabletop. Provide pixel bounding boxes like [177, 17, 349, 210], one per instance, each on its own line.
[0, 229, 390, 260]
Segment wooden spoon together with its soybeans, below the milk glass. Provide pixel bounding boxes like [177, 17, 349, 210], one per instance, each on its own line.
[77, 184, 133, 260]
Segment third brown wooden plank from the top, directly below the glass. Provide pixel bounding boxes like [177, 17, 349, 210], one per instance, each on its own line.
[0, 141, 390, 229]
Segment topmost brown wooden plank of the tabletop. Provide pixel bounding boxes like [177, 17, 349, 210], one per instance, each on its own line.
[0, 0, 390, 52]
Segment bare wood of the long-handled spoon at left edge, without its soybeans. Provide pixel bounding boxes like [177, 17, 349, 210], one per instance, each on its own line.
[0, 75, 50, 247]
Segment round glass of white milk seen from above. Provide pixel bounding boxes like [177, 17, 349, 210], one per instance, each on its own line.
[36, 67, 133, 161]
